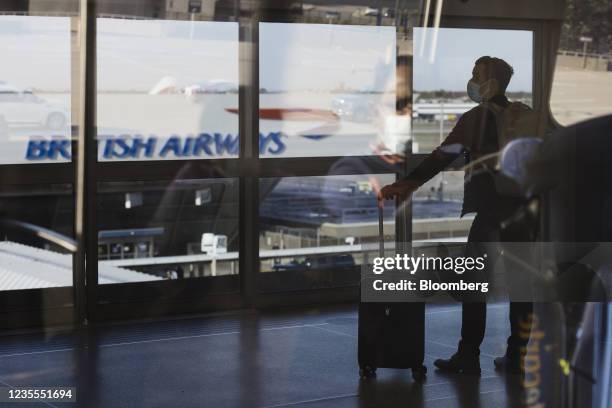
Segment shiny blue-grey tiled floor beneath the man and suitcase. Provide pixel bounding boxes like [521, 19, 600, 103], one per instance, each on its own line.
[0, 304, 521, 408]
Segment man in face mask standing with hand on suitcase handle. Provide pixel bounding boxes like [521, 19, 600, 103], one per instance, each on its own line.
[380, 56, 533, 374]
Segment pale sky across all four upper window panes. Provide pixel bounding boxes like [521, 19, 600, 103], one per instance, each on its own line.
[0, 16, 532, 91]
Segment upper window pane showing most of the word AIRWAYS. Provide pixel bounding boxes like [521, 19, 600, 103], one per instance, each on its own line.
[97, 17, 239, 161]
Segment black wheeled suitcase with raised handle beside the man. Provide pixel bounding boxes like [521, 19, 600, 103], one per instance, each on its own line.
[357, 202, 427, 381]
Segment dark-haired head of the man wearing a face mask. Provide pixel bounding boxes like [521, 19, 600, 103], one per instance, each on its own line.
[468, 56, 514, 102]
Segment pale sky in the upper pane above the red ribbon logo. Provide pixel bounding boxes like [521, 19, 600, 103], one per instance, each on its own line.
[259, 23, 396, 91]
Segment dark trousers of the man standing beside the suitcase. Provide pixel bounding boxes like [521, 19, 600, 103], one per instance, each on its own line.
[459, 214, 533, 357]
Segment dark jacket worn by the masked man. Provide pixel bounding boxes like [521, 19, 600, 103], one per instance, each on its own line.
[405, 95, 520, 216]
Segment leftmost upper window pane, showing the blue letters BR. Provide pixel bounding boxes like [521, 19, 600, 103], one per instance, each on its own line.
[0, 14, 73, 164]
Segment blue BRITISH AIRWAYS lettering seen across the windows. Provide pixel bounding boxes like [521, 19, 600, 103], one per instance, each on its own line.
[25, 132, 287, 161]
